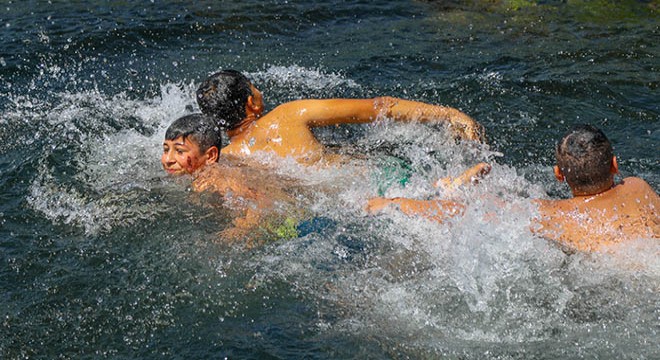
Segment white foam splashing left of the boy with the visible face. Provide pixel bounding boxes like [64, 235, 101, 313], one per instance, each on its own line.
[23, 80, 199, 234]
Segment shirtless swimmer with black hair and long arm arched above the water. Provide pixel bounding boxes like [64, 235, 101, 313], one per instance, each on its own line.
[197, 70, 483, 165]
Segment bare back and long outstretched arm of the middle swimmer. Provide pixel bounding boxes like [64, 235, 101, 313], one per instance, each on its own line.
[221, 97, 483, 165]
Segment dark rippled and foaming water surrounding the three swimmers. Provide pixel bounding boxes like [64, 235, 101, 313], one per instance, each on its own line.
[0, 1, 660, 359]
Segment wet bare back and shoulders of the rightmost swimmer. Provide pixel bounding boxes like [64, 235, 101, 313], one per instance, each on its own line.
[533, 177, 660, 251]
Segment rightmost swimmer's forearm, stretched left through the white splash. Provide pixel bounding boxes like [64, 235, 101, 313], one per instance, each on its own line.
[366, 197, 465, 223]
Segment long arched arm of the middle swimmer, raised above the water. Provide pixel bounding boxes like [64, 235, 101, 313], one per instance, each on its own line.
[270, 97, 484, 141]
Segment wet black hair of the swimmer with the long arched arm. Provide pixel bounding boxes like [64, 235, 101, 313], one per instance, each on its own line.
[197, 70, 252, 130]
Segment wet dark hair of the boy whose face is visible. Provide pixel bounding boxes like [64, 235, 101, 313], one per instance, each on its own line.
[165, 114, 222, 156]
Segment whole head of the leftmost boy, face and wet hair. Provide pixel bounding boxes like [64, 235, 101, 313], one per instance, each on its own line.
[160, 114, 222, 175]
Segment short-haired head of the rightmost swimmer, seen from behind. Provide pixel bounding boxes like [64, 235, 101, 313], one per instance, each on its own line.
[555, 125, 618, 195]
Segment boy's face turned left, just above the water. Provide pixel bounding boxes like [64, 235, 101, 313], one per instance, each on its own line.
[160, 136, 209, 175]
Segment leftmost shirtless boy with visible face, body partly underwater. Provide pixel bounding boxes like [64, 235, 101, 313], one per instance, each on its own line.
[161, 114, 300, 245]
